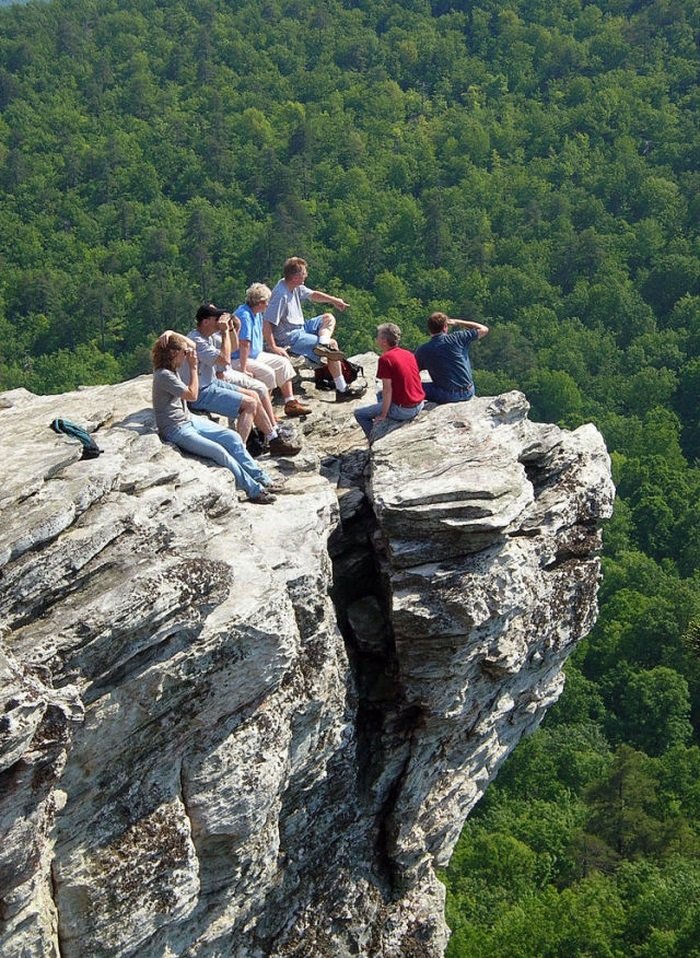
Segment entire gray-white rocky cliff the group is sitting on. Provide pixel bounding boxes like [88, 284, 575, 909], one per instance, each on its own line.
[0, 377, 613, 958]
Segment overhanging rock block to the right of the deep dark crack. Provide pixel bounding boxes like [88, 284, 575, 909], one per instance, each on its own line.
[371, 393, 613, 869]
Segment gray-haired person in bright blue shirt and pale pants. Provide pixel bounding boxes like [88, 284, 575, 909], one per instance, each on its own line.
[231, 283, 311, 416]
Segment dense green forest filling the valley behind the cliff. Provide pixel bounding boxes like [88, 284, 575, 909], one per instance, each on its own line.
[0, 0, 700, 958]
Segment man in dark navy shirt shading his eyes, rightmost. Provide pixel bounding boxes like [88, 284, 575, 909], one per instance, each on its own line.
[416, 313, 489, 405]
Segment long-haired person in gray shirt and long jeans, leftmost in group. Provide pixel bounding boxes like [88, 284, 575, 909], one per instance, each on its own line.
[151, 329, 281, 506]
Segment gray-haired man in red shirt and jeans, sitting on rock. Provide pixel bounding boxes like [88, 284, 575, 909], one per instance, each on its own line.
[355, 323, 425, 439]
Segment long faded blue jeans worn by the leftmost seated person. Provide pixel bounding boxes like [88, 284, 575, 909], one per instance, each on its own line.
[165, 416, 272, 499]
